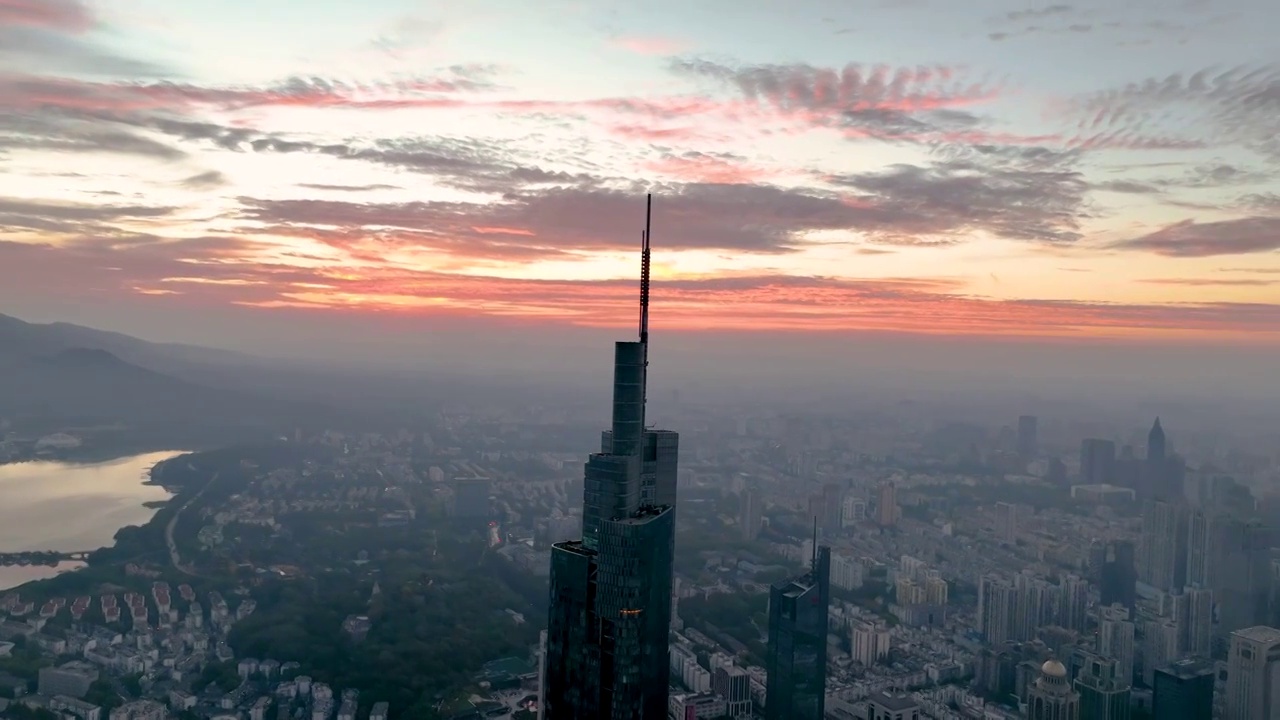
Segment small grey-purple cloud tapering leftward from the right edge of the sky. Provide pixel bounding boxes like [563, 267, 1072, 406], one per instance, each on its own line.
[1110, 217, 1280, 258]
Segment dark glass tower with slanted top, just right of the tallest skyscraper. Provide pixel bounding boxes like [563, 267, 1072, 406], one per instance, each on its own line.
[762, 546, 831, 720]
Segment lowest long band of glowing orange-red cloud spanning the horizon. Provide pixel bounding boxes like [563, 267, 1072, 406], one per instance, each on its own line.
[0, 237, 1280, 337]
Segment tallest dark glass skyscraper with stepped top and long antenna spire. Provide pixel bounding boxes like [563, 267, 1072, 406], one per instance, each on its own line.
[543, 197, 678, 720]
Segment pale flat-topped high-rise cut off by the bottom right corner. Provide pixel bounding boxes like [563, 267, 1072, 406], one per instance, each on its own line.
[1222, 625, 1280, 720]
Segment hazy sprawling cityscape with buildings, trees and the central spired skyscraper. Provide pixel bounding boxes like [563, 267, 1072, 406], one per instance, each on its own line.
[0, 202, 1280, 720]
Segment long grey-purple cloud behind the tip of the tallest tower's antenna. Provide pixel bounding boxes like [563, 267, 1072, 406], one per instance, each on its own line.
[242, 183, 911, 252]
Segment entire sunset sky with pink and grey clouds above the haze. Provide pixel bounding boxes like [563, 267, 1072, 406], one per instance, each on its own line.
[0, 0, 1280, 347]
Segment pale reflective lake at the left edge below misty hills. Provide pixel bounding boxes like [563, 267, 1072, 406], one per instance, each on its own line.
[0, 451, 183, 591]
